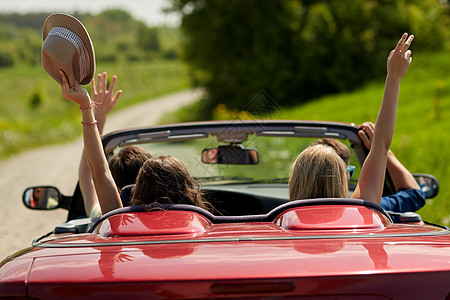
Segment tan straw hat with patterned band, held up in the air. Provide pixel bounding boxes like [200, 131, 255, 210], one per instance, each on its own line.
[41, 13, 95, 87]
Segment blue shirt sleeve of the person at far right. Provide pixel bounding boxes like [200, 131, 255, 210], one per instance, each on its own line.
[380, 189, 425, 213]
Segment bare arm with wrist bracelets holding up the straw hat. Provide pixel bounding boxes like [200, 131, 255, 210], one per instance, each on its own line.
[61, 72, 122, 214]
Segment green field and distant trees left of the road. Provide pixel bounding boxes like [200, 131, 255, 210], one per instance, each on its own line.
[0, 10, 189, 160]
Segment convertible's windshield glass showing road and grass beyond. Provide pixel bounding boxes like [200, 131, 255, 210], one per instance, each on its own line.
[115, 134, 360, 189]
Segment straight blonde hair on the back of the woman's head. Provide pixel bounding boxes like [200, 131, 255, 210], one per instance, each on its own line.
[289, 144, 348, 201]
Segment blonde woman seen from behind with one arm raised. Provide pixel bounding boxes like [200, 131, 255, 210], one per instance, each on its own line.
[289, 33, 414, 204]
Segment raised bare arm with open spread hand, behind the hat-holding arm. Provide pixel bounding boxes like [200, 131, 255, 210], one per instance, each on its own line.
[78, 72, 122, 216]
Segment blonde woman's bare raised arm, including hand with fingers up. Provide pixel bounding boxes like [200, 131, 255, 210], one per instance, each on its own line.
[352, 33, 414, 204]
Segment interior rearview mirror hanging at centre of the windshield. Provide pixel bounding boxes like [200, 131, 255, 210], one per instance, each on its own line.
[202, 145, 259, 165]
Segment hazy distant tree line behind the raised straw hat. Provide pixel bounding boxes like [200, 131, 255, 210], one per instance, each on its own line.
[0, 9, 180, 68]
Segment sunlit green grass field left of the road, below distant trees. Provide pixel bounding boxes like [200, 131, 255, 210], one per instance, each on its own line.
[0, 61, 189, 159]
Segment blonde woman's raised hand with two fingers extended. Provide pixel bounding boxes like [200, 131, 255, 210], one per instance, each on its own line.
[387, 33, 414, 81]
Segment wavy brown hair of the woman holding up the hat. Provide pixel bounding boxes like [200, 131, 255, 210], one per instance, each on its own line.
[131, 155, 211, 210]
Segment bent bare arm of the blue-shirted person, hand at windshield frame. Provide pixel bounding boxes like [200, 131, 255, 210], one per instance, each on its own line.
[358, 122, 420, 191]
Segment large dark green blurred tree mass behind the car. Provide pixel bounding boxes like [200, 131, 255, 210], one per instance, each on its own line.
[171, 0, 449, 119]
